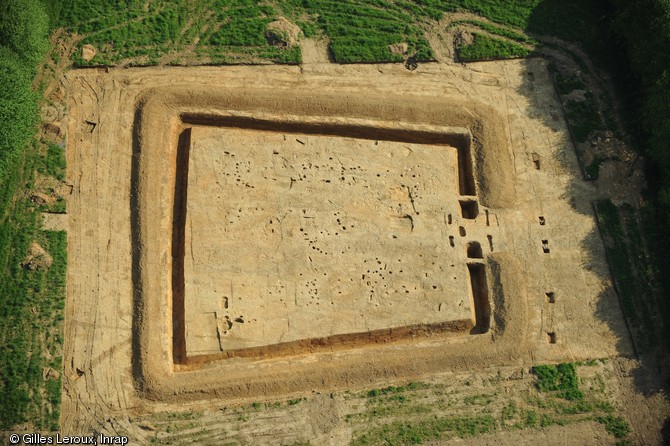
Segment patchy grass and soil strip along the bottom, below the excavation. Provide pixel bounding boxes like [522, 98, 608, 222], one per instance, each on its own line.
[139, 361, 628, 445]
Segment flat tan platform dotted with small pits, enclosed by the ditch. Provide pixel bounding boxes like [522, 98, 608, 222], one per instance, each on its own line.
[177, 126, 474, 357]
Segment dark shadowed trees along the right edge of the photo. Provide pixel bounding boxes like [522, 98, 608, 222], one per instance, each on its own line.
[612, 0, 670, 339]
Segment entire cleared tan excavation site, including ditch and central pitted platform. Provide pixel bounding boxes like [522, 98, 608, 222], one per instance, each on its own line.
[62, 55, 652, 444]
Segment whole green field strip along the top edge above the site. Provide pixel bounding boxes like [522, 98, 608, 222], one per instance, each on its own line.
[44, 0, 608, 66]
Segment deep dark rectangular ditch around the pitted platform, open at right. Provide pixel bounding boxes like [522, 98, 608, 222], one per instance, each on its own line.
[171, 119, 480, 368]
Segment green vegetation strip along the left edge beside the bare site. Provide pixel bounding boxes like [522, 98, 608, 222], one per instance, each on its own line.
[0, 0, 66, 431]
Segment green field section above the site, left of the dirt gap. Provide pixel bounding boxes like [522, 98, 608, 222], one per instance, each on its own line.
[51, 0, 300, 66]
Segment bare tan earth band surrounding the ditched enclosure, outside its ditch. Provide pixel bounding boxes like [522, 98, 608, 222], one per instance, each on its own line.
[62, 59, 630, 435]
